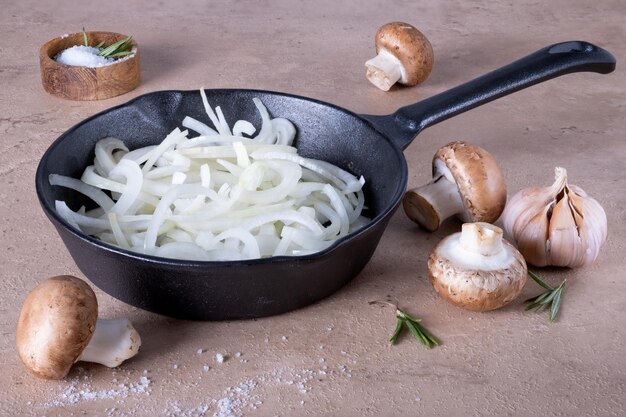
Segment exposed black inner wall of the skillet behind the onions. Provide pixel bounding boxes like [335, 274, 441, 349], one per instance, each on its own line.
[37, 90, 406, 254]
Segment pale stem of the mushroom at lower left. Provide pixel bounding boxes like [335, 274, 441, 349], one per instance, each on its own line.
[76, 318, 141, 368]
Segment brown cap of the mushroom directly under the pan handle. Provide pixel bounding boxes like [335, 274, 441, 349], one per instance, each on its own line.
[433, 141, 506, 223]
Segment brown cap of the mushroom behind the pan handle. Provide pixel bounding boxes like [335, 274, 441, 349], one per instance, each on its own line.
[374, 22, 435, 86]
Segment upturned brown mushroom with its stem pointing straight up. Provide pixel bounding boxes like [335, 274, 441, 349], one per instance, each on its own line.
[428, 223, 528, 311]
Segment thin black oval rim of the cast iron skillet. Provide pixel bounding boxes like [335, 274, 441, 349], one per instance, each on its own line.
[35, 88, 408, 268]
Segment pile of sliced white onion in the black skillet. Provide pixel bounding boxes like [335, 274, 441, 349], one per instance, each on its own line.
[49, 90, 369, 261]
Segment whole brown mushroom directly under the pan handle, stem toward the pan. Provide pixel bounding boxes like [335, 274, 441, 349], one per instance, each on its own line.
[402, 142, 506, 232]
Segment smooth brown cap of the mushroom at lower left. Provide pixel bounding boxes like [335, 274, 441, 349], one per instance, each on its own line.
[16, 275, 98, 379]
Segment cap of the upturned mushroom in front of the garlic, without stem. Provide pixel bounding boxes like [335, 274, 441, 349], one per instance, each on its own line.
[428, 226, 528, 311]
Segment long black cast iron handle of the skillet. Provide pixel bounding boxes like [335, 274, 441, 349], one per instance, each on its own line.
[363, 41, 615, 149]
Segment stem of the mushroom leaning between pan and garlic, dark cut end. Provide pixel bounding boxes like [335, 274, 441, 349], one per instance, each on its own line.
[402, 175, 464, 232]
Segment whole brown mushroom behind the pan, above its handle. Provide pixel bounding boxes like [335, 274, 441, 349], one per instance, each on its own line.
[365, 22, 435, 91]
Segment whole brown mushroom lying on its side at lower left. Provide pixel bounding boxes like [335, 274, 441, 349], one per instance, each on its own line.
[16, 275, 141, 379]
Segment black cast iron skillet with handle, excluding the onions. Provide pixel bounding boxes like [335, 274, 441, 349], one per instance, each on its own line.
[36, 41, 615, 320]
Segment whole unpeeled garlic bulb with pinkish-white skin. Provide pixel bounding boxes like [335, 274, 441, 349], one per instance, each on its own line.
[502, 167, 607, 267]
